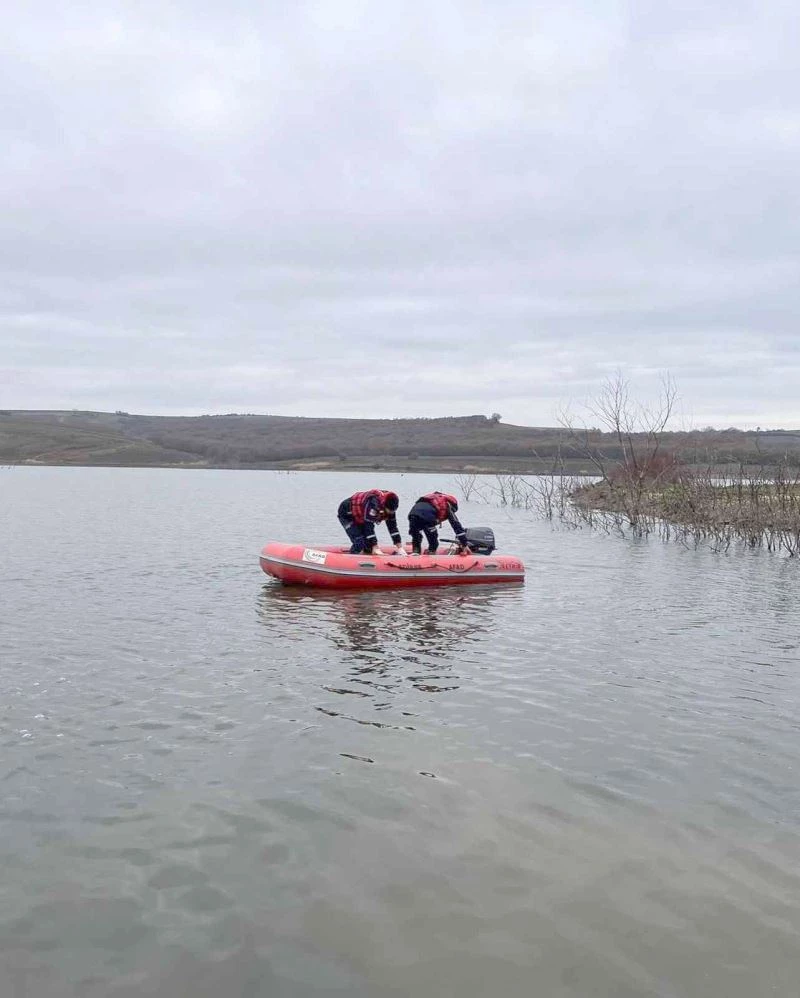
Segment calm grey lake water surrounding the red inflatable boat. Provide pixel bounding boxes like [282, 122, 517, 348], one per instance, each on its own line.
[0, 468, 800, 998]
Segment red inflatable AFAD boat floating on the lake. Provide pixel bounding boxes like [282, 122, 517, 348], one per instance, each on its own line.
[260, 544, 525, 589]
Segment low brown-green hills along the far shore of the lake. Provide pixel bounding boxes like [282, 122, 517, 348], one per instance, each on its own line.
[0, 409, 800, 473]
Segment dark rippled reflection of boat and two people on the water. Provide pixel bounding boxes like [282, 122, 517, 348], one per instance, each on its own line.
[257, 583, 520, 709]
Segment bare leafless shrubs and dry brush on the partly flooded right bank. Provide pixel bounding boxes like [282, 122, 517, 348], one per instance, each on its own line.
[454, 373, 800, 556]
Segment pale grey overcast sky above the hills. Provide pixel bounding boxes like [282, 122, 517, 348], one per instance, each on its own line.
[0, 0, 800, 427]
